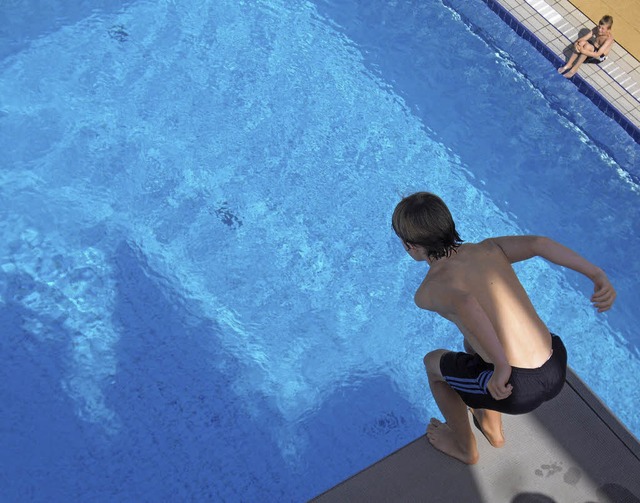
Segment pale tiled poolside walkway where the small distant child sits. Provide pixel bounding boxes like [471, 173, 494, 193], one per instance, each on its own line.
[496, 0, 640, 138]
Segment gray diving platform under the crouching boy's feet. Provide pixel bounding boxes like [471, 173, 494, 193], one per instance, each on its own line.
[312, 371, 640, 503]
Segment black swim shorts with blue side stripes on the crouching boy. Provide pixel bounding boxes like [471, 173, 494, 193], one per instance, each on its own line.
[440, 334, 567, 414]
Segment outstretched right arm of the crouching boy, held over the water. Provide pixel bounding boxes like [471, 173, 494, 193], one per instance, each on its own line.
[492, 236, 616, 313]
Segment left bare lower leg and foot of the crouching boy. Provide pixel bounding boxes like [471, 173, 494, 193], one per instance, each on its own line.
[424, 349, 479, 464]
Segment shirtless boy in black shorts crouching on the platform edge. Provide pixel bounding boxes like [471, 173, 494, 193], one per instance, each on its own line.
[392, 192, 616, 464]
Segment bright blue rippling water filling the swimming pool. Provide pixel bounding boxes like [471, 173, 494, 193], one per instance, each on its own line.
[0, 0, 640, 501]
